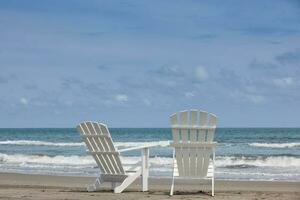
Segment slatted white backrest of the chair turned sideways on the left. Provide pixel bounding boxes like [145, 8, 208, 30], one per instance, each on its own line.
[77, 122, 125, 175]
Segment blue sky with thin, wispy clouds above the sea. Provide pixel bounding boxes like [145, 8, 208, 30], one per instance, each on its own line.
[0, 0, 300, 128]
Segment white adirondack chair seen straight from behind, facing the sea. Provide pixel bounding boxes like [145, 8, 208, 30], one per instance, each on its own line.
[170, 110, 217, 196]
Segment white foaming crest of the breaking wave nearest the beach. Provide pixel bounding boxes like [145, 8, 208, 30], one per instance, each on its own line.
[0, 153, 300, 168]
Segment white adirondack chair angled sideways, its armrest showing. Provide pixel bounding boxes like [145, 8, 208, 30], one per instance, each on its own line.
[77, 122, 153, 193]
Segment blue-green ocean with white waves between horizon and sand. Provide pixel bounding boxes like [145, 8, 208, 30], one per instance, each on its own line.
[0, 128, 300, 181]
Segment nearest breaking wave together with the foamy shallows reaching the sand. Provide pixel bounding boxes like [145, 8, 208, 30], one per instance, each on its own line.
[0, 153, 300, 181]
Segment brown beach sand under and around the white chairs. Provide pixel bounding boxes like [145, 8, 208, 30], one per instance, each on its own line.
[0, 173, 300, 200]
